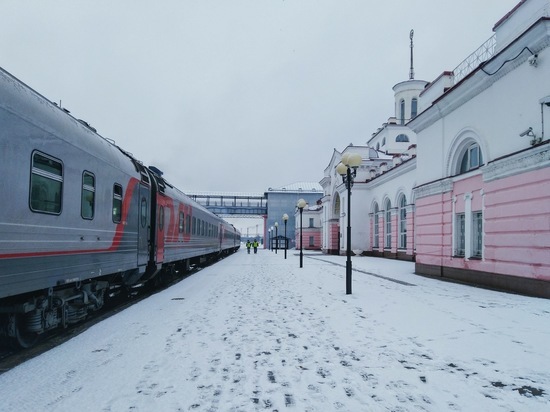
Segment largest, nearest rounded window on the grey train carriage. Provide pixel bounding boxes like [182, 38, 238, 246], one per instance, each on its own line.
[30, 152, 63, 215]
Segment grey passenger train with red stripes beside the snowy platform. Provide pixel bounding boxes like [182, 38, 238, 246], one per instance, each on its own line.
[0, 68, 240, 347]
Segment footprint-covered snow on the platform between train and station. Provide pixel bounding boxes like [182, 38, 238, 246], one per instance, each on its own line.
[0, 249, 550, 411]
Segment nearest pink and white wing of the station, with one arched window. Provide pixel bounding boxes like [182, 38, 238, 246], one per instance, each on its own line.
[408, 0, 550, 297]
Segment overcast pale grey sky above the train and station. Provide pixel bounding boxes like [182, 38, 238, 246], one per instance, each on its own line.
[0, 0, 519, 192]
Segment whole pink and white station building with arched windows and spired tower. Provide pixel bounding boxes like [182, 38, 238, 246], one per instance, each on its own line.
[320, 0, 550, 297]
